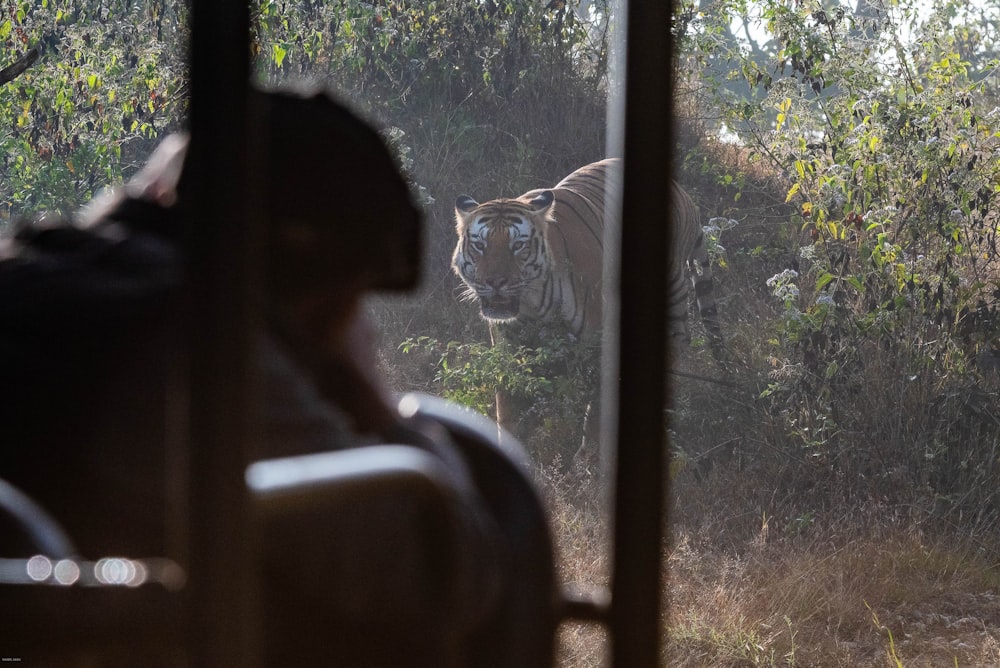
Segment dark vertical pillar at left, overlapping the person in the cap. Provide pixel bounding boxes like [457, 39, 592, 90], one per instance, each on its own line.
[185, 0, 259, 667]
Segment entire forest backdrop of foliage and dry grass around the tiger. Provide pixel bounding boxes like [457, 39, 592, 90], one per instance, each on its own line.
[0, 0, 1000, 666]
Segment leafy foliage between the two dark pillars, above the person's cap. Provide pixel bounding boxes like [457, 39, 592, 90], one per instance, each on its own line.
[254, 0, 606, 111]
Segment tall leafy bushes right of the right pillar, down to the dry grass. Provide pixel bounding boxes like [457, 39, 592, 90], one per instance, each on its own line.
[674, 0, 1000, 526]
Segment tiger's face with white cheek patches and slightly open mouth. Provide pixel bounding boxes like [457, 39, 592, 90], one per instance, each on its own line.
[452, 190, 554, 322]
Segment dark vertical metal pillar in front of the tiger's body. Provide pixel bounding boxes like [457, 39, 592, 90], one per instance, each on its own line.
[610, 2, 672, 668]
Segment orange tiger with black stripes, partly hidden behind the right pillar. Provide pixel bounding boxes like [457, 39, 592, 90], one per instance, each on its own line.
[452, 158, 722, 357]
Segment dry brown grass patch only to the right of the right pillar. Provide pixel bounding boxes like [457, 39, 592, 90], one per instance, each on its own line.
[667, 523, 1000, 666]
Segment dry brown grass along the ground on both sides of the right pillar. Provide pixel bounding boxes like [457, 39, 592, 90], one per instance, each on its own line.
[543, 462, 1000, 668]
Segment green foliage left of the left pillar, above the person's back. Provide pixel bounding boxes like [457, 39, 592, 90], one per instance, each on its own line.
[0, 0, 187, 224]
